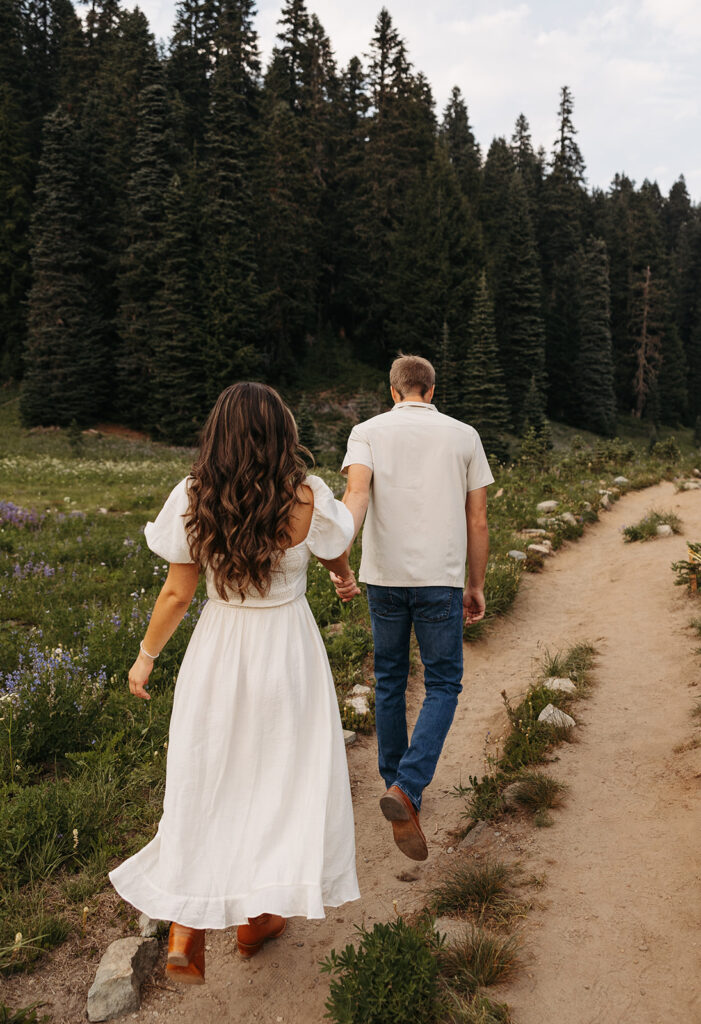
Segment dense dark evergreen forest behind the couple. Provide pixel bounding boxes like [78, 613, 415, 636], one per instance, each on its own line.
[0, 0, 701, 454]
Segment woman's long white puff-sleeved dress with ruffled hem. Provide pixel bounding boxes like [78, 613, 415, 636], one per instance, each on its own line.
[109, 476, 360, 928]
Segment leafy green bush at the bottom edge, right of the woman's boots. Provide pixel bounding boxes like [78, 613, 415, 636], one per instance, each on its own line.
[321, 918, 441, 1024]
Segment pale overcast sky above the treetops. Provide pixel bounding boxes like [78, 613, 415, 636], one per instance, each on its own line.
[130, 0, 701, 202]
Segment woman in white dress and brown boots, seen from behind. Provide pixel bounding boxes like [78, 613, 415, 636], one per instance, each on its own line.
[109, 383, 359, 984]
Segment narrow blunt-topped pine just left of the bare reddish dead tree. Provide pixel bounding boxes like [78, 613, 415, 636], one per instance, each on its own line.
[575, 238, 616, 437]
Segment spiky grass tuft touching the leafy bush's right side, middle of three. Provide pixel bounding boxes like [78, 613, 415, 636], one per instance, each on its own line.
[438, 925, 521, 994]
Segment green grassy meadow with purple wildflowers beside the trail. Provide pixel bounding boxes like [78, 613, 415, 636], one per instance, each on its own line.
[0, 387, 699, 972]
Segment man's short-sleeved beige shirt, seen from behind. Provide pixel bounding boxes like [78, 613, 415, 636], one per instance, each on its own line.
[341, 401, 494, 587]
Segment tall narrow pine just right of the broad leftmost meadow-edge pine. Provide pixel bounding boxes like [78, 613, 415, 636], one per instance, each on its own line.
[117, 65, 173, 426]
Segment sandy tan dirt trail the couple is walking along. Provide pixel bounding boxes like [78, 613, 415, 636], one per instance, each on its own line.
[3, 483, 701, 1024]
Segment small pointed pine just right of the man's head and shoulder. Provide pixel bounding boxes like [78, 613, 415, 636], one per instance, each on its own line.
[464, 274, 510, 462]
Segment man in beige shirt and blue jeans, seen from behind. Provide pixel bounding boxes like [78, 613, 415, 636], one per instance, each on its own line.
[332, 355, 493, 860]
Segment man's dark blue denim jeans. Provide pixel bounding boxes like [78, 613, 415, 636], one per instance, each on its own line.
[367, 584, 463, 810]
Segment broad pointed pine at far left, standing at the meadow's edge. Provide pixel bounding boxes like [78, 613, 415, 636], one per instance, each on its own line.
[20, 108, 106, 426]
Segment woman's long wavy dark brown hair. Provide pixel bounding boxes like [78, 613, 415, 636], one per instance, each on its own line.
[185, 381, 308, 600]
